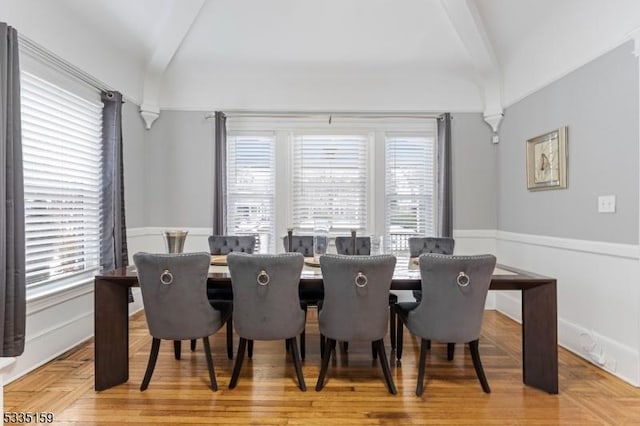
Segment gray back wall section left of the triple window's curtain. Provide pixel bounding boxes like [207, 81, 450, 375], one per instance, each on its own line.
[145, 111, 214, 228]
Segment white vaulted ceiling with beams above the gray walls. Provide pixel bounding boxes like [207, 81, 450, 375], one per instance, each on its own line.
[0, 0, 640, 112]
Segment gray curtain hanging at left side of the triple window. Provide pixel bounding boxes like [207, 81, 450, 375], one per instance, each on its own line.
[213, 111, 227, 235]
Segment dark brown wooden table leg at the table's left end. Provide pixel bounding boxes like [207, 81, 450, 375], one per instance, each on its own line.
[94, 279, 129, 391]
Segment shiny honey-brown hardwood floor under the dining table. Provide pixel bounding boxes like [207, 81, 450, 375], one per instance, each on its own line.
[4, 310, 640, 425]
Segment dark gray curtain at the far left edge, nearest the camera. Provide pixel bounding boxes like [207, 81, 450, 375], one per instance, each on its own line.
[0, 22, 26, 357]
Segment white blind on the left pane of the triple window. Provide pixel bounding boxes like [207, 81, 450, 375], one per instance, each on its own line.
[227, 135, 276, 253]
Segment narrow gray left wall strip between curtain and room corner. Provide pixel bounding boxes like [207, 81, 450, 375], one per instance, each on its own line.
[122, 102, 146, 228]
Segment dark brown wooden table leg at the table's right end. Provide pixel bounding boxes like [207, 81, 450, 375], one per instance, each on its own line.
[522, 280, 558, 394]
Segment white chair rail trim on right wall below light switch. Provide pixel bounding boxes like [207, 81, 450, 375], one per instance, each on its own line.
[496, 231, 640, 259]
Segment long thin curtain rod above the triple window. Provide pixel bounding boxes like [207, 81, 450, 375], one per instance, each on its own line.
[205, 111, 442, 121]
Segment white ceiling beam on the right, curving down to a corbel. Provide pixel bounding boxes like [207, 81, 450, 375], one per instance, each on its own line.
[441, 0, 503, 132]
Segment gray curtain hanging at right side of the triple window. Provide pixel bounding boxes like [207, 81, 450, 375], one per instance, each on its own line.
[437, 112, 453, 238]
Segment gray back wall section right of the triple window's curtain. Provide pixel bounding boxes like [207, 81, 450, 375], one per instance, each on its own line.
[451, 113, 498, 229]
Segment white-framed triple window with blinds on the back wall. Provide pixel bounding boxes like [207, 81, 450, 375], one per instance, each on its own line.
[227, 114, 437, 252]
